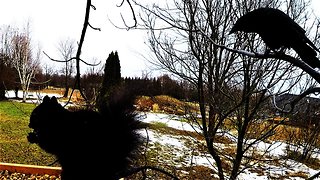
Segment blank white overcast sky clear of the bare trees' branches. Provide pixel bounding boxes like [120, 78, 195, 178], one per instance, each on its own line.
[0, 0, 320, 77]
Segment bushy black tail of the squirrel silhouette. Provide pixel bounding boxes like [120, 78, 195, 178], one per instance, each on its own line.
[100, 88, 142, 178]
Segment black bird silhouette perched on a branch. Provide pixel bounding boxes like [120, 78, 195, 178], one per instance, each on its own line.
[230, 8, 320, 68]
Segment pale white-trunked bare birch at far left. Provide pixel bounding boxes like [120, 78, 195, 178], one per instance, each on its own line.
[2, 24, 41, 102]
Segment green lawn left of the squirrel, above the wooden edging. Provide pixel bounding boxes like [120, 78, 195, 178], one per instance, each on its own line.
[0, 101, 58, 166]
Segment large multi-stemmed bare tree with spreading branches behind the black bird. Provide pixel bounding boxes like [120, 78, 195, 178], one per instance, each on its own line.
[135, 0, 315, 179]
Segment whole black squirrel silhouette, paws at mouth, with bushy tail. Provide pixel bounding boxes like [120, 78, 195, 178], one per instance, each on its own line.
[28, 93, 141, 180]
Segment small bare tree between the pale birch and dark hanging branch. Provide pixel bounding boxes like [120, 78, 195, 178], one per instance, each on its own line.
[58, 39, 76, 97]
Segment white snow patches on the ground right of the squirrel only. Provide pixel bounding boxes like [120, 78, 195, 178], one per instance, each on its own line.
[141, 113, 318, 180]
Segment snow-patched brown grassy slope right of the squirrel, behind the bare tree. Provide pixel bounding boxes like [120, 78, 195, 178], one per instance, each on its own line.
[3, 92, 320, 180]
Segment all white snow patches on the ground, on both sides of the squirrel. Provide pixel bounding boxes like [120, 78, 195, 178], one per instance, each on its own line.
[6, 91, 319, 180]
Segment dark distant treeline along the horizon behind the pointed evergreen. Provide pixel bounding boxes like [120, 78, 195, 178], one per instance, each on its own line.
[31, 73, 197, 101]
